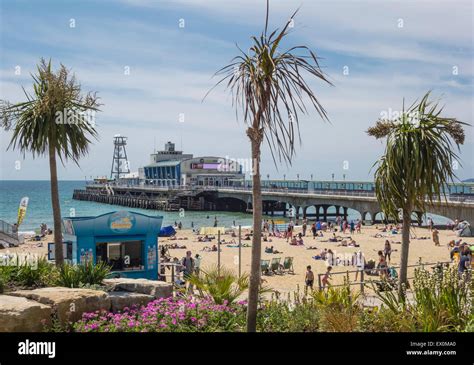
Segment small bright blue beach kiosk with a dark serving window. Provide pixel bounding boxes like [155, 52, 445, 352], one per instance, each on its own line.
[59, 211, 163, 280]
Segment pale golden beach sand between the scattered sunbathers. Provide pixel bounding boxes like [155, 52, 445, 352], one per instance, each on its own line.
[6, 226, 456, 293]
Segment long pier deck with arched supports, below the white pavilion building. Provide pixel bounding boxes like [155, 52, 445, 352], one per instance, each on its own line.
[73, 184, 474, 222]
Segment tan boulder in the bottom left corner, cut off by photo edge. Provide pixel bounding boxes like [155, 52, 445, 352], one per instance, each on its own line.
[0, 295, 52, 332]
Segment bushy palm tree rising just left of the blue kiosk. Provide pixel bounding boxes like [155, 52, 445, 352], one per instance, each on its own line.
[0, 59, 100, 266]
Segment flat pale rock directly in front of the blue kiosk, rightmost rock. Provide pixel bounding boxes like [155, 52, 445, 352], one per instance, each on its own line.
[103, 278, 173, 299]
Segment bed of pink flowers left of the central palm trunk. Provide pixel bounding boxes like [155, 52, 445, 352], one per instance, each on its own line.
[73, 298, 246, 332]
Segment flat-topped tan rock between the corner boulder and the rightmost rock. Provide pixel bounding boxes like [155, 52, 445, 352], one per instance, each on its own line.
[9, 287, 110, 324]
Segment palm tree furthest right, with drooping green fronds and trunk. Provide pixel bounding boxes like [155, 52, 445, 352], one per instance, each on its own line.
[367, 92, 466, 297]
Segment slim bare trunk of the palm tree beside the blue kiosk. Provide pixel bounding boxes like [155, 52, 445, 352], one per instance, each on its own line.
[49, 143, 64, 266]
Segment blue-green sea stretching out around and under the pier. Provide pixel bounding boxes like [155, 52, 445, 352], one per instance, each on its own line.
[0, 180, 446, 231]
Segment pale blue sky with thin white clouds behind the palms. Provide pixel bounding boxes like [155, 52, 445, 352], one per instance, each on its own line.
[0, 0, 474, 180]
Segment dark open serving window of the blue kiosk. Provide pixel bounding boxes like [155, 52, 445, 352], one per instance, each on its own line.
[96, 241, 144, 271]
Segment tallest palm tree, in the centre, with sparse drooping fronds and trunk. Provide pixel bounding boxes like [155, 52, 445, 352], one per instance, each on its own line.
[211, 0, 331, 332]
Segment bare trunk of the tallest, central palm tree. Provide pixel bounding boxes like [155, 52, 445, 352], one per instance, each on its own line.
[247, 129, 262, 332]
